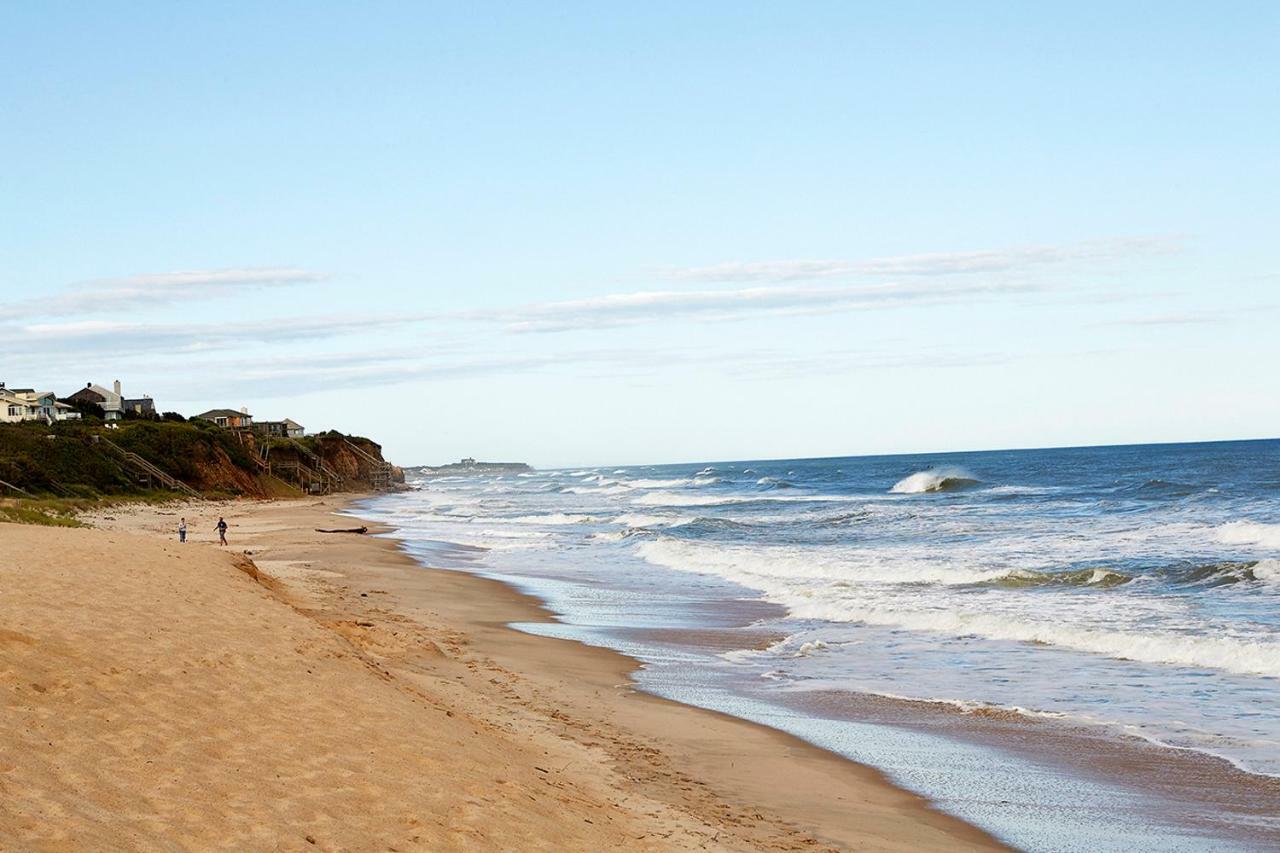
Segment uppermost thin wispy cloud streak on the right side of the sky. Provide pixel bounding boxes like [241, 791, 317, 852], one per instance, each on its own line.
[666, 237, 1180, 283]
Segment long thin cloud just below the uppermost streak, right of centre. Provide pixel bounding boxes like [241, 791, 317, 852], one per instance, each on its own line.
[454, 282, 1037, 332]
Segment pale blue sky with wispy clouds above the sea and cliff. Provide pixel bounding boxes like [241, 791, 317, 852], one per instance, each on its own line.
[0, 1, 1280, 466]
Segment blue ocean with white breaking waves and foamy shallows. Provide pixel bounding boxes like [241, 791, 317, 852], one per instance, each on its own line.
[360, 441, 1280, 850]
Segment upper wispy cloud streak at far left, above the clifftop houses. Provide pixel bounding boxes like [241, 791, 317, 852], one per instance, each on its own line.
[3, 266, 325, 316]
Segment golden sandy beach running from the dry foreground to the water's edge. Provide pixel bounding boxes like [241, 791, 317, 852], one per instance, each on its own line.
[0, 500, 1000, 852]
